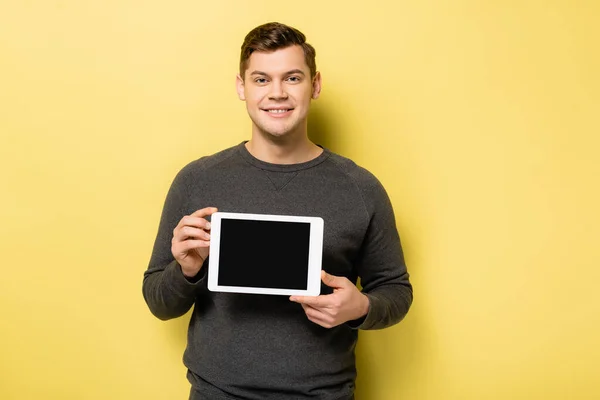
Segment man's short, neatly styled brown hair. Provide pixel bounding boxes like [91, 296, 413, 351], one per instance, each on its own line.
[240, 22, 317, 79]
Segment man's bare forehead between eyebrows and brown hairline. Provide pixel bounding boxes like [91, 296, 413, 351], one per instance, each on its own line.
[247, 46, 310, 75]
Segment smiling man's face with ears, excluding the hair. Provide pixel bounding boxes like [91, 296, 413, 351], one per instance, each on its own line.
[237, 46, 321, 138]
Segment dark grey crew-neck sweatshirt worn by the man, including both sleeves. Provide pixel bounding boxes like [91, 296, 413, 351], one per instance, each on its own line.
[143, 143, 412, 400]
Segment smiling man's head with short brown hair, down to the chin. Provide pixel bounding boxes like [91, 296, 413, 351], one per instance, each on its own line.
[237, 23, 321, 138]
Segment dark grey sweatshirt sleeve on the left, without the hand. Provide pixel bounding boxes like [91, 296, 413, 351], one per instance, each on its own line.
[142, 165, 206, 320]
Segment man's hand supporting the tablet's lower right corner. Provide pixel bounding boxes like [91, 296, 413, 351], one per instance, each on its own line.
[290, 271, 369, 328]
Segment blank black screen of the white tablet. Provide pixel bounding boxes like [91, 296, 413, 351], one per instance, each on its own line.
[218, 218, 310, 290]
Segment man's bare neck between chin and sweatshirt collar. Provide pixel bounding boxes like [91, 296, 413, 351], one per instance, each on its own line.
[246, 134, 323, 164]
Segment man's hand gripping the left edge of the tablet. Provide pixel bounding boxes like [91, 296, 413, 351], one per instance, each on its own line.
[171, 207, 217, 278]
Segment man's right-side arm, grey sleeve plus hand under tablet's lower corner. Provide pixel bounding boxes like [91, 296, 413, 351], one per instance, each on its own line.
[290, 178, 413, 329]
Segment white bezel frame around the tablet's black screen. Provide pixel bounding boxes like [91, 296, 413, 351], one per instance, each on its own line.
[208, 212, 324, 296]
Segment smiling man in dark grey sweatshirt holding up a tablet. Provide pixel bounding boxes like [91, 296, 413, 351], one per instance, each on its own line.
[143, 23, 412, 400]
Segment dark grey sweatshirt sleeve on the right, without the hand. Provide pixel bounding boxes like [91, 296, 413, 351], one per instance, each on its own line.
[350, 177, 413, 329]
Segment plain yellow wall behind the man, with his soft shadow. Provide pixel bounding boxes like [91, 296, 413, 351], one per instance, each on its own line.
[0, 0, 600, 400]
